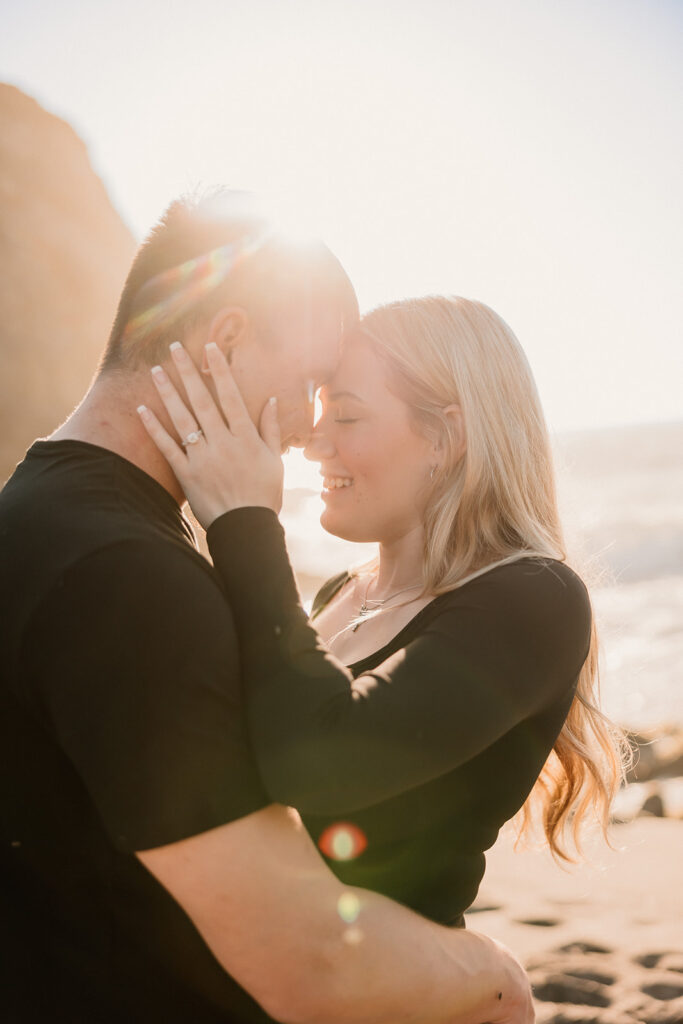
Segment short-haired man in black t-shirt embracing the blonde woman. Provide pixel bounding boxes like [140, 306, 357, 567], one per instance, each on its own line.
[0, 196, 530, 1024]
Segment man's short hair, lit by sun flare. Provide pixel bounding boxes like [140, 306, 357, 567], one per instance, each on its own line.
[100, 189, 358, 370]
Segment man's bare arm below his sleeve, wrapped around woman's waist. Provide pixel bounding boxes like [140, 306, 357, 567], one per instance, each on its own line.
[137, 806, 533, 1024]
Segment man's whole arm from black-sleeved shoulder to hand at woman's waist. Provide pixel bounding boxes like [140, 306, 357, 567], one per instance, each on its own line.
[34, 542, 530, 1024]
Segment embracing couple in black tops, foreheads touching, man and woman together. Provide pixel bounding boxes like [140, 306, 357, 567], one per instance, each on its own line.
[0, 194, 618, 1024]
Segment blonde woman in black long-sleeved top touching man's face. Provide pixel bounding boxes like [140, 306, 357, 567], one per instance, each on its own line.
[141, 298, 620, 925]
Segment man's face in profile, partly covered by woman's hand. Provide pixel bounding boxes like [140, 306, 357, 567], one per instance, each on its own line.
[230, 309, 341, 450]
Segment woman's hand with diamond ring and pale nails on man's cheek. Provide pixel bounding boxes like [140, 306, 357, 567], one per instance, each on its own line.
[137, 342, 284, 529]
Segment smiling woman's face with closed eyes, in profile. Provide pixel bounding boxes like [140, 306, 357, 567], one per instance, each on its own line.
[305, 340, 436, 544]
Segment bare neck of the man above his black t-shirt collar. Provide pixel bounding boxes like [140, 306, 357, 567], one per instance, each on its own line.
[49, 372, 185, 505]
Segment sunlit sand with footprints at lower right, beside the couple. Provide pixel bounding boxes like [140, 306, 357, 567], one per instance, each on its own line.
[467, 816, 683, 1024]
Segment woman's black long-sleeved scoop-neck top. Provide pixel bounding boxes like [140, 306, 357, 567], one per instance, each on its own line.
[208, 508, 591, 924]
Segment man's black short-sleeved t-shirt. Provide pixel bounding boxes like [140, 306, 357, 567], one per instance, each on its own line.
[0, 441, 270, 1024]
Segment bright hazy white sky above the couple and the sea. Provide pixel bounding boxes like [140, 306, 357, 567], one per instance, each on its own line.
[0, 0, 683, 456]
